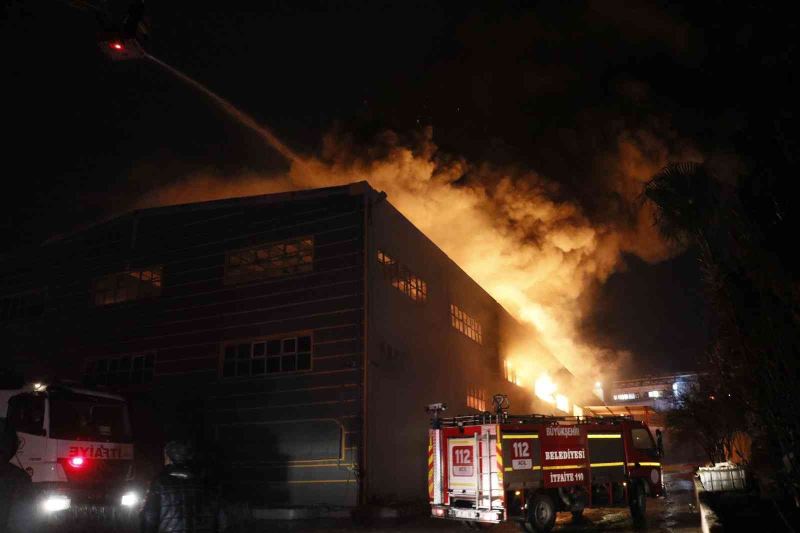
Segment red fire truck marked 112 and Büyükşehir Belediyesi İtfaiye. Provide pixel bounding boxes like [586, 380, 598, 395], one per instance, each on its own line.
[428, 395, 664, 532]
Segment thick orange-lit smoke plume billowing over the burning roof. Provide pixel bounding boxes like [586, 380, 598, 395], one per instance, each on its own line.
[139, 124, 699, 386]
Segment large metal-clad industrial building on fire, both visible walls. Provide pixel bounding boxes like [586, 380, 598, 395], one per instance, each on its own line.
[0, 182, 570, 506]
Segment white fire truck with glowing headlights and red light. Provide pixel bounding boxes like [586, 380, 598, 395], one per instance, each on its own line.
[0, 383, 140, 515]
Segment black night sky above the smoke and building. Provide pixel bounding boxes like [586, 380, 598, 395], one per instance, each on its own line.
[0, 1, 781, 374]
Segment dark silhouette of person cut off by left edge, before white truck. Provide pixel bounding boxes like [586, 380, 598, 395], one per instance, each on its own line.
[0, 420, 34, 533]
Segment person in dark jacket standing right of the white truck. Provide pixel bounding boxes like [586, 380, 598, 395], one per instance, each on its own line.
[142, 441, 227, 533]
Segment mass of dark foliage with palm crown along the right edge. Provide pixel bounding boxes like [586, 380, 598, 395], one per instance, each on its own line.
[644, 164, 800, 501]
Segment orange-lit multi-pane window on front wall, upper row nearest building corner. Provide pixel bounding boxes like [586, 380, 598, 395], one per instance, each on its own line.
[225, 237, 314, 284]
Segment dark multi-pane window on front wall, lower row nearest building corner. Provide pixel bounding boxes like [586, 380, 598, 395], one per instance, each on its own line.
[222, 335, 311, 378]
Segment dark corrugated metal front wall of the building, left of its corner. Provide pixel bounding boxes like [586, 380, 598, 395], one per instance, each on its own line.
[0, 187, 364, 505]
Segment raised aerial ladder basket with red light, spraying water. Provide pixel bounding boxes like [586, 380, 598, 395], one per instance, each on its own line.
[67, 0, 150, 61]
